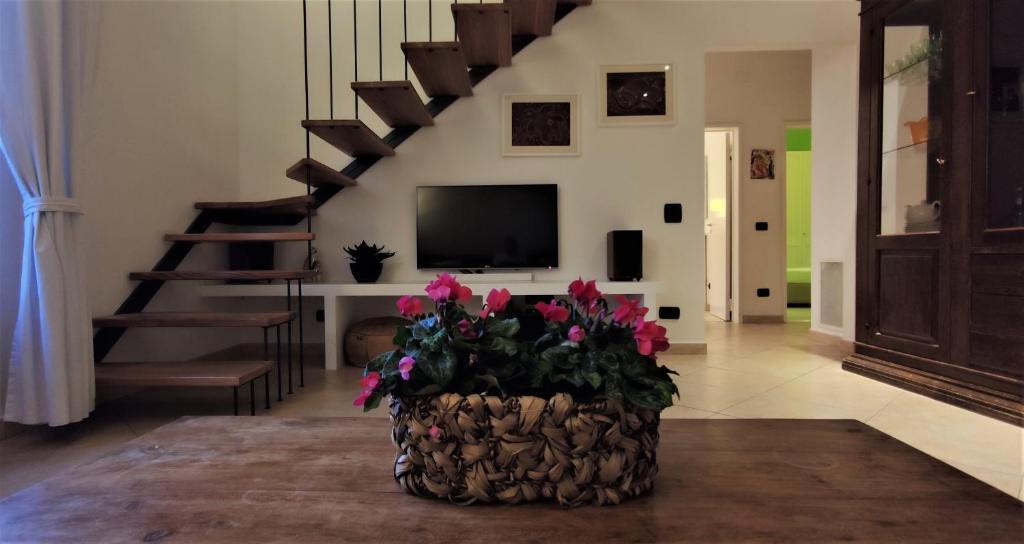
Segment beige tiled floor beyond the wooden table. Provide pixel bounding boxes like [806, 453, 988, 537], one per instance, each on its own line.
[0, 320, 1024, 500]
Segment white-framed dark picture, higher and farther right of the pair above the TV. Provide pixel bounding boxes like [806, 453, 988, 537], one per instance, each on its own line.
[597, 64, 676, 126]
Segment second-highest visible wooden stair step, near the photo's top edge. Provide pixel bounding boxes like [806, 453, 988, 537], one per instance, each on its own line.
[452, 3, 512, 67]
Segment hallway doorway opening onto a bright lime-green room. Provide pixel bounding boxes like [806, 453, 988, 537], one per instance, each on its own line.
[785, 125, 811, 322]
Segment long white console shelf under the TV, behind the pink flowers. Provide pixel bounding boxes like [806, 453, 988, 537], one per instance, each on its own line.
[200, 276, 660, 370]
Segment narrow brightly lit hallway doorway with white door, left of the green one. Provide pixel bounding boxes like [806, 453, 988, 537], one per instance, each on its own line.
[705, 128, 738, 321]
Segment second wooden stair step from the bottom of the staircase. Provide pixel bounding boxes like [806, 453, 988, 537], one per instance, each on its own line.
[92, 311, 295, 328]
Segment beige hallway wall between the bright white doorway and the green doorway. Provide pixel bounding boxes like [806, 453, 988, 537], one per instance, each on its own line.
[705, 50, 811, 321]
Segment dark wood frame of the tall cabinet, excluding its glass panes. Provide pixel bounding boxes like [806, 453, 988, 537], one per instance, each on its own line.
[844, 0, 1024, 425]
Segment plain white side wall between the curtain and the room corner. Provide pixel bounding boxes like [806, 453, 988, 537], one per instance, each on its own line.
[72, 1, 247, 360]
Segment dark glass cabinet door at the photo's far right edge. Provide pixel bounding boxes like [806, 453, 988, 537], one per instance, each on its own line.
[982, 0, 1024, 229]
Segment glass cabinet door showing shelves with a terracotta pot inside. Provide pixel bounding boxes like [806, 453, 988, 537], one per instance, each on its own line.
[879, 0, 945, 235]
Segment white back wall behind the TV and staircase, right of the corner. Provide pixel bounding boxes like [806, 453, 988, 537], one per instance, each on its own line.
[230, 1, 857, 342]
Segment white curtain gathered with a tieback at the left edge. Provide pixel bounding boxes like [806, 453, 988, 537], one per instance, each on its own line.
[0, 1, 95, 425]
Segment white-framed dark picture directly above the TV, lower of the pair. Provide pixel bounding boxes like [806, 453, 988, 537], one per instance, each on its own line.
[502, 94, 580, 157]
